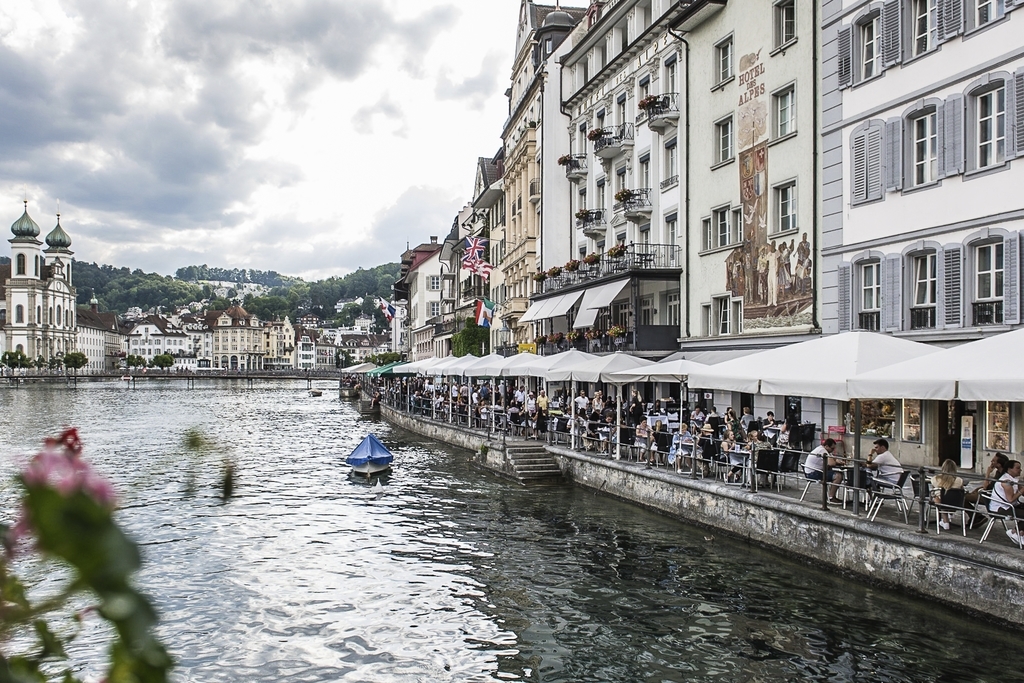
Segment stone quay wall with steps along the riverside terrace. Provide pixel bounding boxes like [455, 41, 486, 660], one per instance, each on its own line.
[381, 404, 1024, 629]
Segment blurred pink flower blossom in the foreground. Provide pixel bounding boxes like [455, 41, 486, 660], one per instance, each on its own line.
[22, 427, 115, 508]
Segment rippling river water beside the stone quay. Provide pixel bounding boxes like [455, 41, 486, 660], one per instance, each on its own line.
[0, 381, 1024, 682]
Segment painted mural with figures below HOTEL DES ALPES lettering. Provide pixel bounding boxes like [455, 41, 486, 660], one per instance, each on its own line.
[725, 51, 813, 330]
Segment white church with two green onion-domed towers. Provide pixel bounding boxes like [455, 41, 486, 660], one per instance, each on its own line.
[0, 202, 76, 360]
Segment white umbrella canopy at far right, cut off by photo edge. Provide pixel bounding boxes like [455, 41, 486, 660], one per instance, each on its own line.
[847, 330, 1024, 401]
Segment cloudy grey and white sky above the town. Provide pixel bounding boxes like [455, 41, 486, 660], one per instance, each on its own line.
[0, 0, 587, 279]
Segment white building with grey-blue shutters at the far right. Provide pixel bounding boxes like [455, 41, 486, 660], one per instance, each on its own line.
[821, 0, 1024, 465]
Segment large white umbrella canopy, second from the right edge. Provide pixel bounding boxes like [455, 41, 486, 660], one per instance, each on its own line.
[688, 332, 937, 400]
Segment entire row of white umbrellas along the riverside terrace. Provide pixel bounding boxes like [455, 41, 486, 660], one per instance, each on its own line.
[391, 330, 1024, 401]
